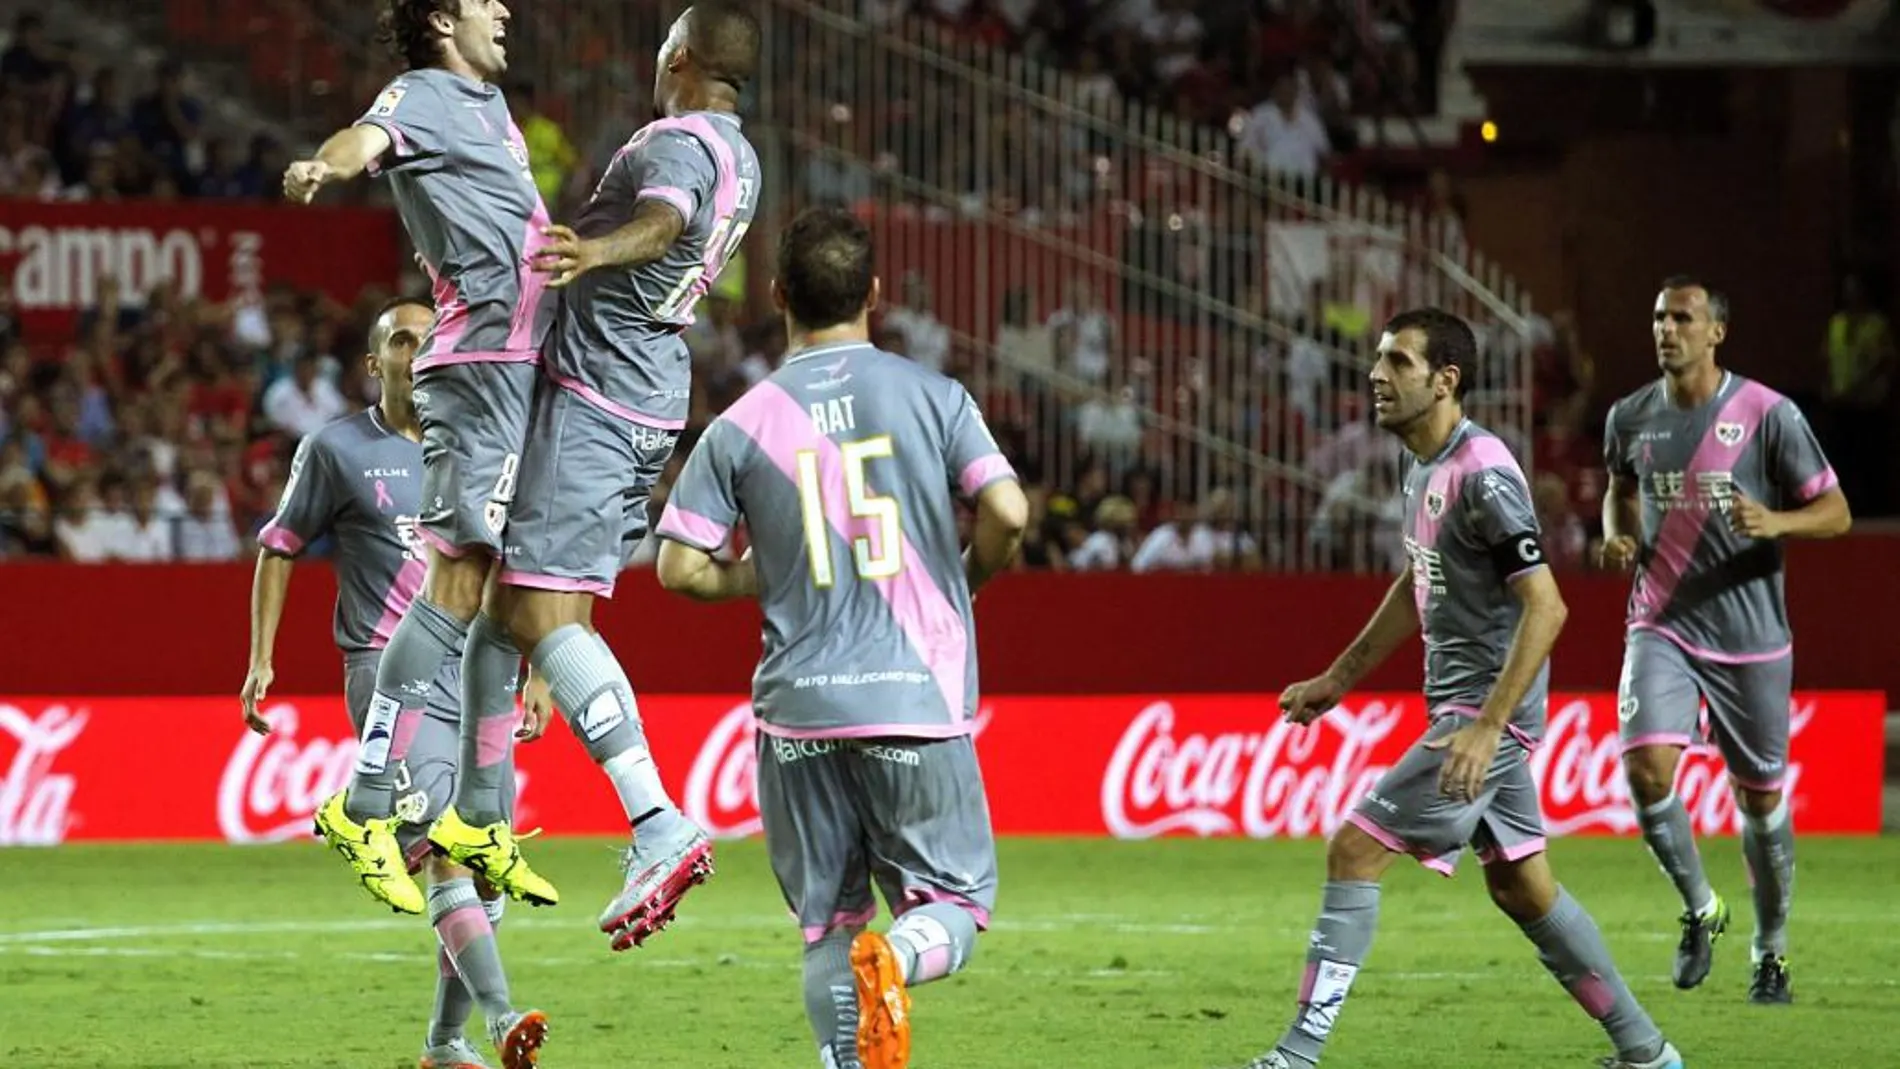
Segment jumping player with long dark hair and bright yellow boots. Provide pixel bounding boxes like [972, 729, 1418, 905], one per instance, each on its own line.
[283, 0, 559, 913]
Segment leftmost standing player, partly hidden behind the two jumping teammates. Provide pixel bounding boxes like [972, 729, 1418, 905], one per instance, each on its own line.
[239, 298, 547, 1069]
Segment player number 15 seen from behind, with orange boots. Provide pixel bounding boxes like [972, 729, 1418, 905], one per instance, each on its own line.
[657, 209, 1028, 1069]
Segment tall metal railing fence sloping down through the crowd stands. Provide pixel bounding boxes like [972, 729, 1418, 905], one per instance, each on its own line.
[133, 0, 1531, 570]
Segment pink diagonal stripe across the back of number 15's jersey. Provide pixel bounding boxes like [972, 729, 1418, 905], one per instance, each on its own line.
[726, 380, 969, 723]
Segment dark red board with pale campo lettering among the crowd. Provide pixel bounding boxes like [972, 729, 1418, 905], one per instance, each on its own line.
[0, 199, 403, 342]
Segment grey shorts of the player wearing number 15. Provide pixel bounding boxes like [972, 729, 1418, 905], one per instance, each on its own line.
[758, 731, 996, 942]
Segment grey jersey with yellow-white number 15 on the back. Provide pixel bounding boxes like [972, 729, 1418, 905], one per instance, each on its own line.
[657, 344, 1015, 739]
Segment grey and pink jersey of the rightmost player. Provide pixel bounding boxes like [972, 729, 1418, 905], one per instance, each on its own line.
[1604, 372, 1839, 663]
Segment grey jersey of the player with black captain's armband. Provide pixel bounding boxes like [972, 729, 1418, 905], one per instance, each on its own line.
[1404, 420, 1550, 741]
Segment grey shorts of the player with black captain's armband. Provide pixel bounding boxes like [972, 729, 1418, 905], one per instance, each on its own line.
[1347, 714, 1545, 875]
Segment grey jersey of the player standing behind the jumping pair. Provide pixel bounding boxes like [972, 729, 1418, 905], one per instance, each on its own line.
[257, 408, 428, 653]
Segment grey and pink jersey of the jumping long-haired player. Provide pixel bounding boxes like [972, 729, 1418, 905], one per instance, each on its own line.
[357, 68, 555, 370]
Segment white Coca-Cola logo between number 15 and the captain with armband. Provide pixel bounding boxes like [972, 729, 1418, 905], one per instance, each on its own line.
[1102, 701, 1404, 839]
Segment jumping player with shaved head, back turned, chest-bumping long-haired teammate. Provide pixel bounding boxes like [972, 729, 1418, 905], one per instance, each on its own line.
[431, 2, 760, 949]
